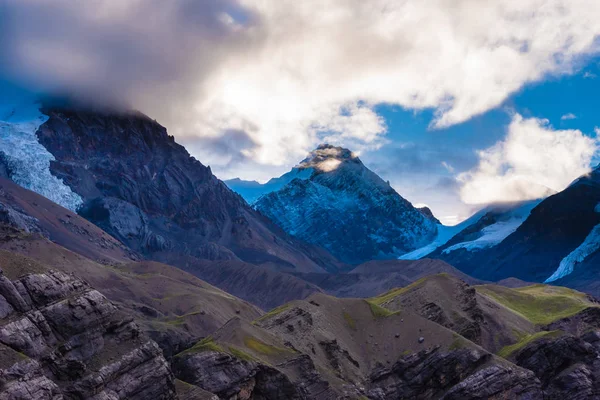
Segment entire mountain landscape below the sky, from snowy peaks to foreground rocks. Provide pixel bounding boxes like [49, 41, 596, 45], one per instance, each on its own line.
[0, 101, 600, 400]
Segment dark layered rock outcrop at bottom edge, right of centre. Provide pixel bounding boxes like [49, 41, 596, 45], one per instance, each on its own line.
[368, 346, 542, 400]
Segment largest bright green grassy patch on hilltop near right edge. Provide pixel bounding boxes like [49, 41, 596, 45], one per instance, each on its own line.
[476, 284, 596, 325]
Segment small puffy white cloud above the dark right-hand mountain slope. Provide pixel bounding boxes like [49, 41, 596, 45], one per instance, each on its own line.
[458, 114, 599, 204]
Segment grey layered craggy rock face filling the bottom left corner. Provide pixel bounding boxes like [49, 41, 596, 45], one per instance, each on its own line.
[0, 271, 175, 400]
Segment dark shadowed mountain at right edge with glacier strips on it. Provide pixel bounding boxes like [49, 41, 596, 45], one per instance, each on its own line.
[428, 168, 600, 295]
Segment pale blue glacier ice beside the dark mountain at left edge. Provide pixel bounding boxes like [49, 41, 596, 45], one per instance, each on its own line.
[0, 101, 83, 211]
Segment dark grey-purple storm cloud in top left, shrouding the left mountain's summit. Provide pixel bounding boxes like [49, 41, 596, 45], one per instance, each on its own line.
[0, 0, 252, 111]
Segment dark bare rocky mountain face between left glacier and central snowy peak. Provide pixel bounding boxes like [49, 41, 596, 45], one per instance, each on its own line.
[31, 109, 340, 272]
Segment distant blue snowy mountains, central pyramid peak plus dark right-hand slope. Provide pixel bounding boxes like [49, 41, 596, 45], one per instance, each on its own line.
[226, 141, 600, 295]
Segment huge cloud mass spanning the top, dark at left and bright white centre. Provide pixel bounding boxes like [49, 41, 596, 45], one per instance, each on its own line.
[0, 0, 600, 178]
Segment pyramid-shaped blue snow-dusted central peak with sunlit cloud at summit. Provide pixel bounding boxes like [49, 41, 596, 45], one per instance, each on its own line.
[254, 145, 436, 264]
